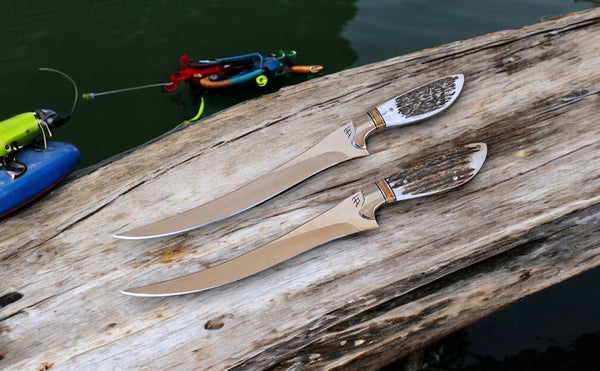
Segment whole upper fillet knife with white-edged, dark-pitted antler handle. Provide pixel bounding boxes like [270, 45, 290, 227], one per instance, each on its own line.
[115, 75, 464, 239]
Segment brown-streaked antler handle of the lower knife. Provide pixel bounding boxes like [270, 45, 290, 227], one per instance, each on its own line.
[386, 143, 487, 200]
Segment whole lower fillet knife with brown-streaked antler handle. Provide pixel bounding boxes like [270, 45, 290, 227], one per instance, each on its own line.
[121, 143, 487, 297]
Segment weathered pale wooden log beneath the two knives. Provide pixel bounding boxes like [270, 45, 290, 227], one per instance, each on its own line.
[0, 9, 600, 369]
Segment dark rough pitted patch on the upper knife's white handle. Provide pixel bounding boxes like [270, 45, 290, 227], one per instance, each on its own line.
[396, 76, 457, 117]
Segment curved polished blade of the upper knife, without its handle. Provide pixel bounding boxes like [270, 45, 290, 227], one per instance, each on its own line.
[115, 122, 369, 239]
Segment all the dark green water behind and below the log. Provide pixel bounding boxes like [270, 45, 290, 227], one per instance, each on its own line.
[0, 0, 600, 369]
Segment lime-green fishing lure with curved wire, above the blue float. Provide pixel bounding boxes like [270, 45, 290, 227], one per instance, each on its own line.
[0, 67, 78, 179]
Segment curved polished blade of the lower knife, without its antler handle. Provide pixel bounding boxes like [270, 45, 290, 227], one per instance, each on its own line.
[121, 187, 385, 297]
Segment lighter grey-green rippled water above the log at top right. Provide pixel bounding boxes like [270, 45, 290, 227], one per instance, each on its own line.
[342, 0, 591, 66]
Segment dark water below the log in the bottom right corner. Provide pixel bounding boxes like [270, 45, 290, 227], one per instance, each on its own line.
[425, 269, 600, 371]
